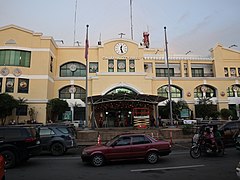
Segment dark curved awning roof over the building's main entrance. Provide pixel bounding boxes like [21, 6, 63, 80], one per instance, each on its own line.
[88, 94, 167, 105]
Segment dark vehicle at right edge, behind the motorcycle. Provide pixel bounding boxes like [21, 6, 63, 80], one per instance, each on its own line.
[219, 120, 240, 146]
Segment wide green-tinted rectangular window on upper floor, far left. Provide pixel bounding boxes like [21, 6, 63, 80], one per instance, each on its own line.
[0, 49, 31, 67]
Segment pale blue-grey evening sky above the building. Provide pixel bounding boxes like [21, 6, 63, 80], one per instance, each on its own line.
[0, 0, 240, 56]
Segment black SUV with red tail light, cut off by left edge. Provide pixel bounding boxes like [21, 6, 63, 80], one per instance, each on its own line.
[0, 126, 41, 168]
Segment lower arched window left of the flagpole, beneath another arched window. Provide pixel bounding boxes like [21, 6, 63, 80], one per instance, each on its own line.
[59, 85, 86, 102]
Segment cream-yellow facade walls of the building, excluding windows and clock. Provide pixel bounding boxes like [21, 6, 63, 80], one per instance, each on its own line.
[0, 25, 240, 123]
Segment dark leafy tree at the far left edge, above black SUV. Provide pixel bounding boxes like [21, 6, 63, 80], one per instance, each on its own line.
[0, 93, 18, 125]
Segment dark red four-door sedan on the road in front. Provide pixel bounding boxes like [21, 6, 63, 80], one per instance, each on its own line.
[81, 134, 171, 167]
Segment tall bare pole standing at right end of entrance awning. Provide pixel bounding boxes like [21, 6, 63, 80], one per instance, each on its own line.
[164, 27, 173, 126]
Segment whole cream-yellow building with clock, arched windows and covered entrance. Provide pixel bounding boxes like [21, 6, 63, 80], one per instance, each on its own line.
[0, 25, 240, 127]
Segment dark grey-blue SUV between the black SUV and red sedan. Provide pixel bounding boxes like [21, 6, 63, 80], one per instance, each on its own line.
[39, 124, 77, 156]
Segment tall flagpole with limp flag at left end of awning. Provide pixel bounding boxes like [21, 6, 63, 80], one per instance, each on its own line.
[85, 25, 89, 128]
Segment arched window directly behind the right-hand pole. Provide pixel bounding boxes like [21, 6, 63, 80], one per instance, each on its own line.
[157, 85, 182, 98]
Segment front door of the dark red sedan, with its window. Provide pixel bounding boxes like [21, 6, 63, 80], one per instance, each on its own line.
[105, 136, 131, 160]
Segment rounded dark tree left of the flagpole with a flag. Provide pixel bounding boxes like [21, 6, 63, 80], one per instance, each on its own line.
[47, 98, 68, 122]
